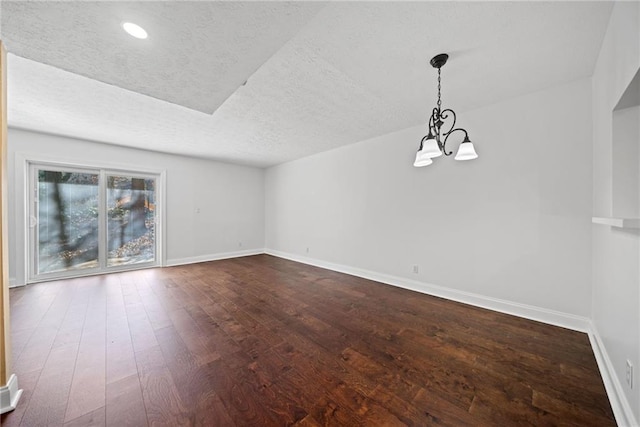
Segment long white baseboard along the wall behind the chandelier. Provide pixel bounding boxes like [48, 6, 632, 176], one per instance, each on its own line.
[265, 249, 591, 332]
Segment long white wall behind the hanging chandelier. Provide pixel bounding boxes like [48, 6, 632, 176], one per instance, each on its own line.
[266, 79, 592, 326]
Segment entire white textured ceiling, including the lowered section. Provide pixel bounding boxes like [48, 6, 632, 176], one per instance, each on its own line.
[0, 1, 612, 167]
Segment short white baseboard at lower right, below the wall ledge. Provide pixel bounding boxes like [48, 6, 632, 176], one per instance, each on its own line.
[589, 322, 640, 427]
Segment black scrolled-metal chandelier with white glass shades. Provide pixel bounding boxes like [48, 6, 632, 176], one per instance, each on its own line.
[413, 53, 478, 167]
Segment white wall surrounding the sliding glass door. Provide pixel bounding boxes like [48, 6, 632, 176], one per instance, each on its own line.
[8, 129, 264, 285]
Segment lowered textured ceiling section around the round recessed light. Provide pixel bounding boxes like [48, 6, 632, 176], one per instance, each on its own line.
[2, 1, 321, 114]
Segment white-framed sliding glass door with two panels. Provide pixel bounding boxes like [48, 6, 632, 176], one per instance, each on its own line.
[29, 164, 159, 281]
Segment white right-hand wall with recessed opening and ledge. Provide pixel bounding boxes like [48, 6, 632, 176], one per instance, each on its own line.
[592, 2, 640, 425]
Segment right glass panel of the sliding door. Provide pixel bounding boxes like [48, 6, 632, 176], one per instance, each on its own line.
[107, 175, 156, 267]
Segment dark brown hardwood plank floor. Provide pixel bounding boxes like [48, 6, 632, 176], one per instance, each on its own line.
[2, 255, 615, 427]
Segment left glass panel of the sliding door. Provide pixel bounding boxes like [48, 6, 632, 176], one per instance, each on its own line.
[35, 169, 99, 274]
